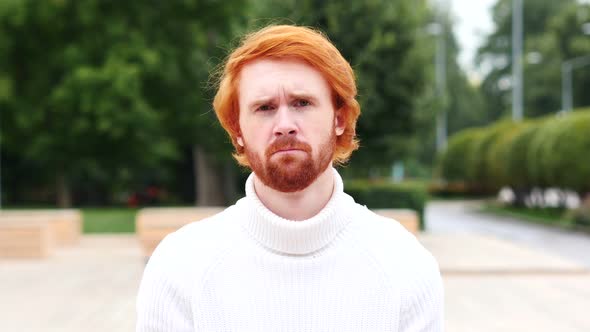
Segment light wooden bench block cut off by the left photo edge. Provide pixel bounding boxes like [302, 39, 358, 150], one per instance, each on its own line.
[0, 216, 55, 258]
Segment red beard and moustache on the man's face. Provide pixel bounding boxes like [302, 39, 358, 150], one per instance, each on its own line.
[244, 131, 336, 193]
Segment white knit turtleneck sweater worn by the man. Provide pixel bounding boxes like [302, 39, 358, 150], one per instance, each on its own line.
[137, 171, 443, 332]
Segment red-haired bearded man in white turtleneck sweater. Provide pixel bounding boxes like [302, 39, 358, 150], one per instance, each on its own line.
[137, 26, 443, 331]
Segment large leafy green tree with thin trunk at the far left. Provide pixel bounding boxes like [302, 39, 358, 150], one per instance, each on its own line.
[0, 1, 173, 206]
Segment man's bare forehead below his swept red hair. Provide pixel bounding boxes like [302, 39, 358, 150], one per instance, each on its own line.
[238, 59, 330, 99]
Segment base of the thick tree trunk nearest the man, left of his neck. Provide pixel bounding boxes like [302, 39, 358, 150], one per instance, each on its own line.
[193, 145, 226, 206]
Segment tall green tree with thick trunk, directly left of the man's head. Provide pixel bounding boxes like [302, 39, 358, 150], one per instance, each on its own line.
[123, 0, 247, 205]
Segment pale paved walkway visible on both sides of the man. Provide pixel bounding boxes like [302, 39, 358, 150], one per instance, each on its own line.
[0, 203, 590, 332]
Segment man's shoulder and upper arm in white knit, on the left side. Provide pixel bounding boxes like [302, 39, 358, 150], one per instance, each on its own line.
[137, 206, 245, 331]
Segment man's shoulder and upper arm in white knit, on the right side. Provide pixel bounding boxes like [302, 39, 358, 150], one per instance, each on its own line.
[353, 206, 444, 331]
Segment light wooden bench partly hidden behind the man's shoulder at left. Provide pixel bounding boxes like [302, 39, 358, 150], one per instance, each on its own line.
[135, 207, 225, 257]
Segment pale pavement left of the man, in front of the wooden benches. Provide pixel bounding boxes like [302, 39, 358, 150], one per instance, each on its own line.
[0, 235, 144, 332]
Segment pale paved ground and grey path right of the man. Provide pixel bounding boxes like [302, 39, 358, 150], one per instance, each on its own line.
[420, 202, 590, 332]
